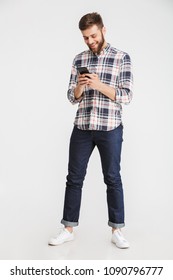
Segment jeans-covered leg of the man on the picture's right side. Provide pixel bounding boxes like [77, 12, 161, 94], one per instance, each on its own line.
[96, 125, 124, 228]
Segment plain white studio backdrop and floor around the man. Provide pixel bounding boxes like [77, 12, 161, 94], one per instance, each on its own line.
[0, 0, 173, 259]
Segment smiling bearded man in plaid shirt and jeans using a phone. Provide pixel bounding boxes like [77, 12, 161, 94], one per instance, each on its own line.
[49, 13, 133, 248]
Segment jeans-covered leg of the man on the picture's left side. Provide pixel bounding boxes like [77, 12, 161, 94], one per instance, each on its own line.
[61, 127, 94, 230]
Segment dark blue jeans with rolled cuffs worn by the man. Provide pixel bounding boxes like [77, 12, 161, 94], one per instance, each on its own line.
[61, 125, 124, 228]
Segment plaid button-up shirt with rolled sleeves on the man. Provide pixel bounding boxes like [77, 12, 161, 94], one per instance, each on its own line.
[67, 44, 133, 131]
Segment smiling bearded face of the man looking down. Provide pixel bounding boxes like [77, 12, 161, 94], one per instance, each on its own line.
[82, 25, 106, 54]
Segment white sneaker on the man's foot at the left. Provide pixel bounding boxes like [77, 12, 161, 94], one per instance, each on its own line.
[49, 228, 74, 246]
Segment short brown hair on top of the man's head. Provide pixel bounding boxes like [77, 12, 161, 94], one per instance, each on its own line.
[79, 13, 104, 30]
